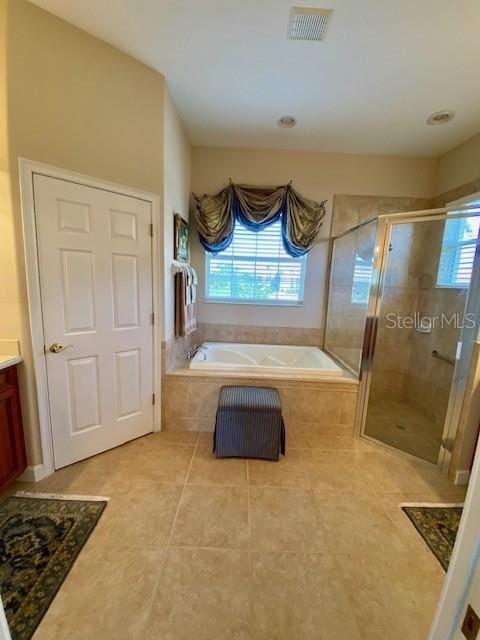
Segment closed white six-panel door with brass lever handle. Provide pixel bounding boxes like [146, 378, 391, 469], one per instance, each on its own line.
[33, 175, 153, 469]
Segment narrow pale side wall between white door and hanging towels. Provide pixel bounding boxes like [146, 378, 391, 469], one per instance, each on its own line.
[162, 88, 193, 340]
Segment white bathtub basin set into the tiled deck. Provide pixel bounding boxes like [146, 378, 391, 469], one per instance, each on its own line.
[190, 342, 344, 378]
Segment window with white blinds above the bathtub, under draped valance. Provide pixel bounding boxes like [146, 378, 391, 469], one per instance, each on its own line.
[205, 221, 307, 305]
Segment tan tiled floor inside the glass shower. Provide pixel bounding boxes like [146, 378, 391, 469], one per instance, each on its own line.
[365, 399, 442, 464]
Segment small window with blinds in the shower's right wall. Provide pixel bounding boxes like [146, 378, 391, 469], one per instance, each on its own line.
[437, 211, 480, 288]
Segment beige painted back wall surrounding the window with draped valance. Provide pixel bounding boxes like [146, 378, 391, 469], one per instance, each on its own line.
[192, 147, 436, 328]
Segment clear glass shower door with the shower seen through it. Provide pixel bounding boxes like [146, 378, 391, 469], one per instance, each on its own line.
[363, 214, 480, 464]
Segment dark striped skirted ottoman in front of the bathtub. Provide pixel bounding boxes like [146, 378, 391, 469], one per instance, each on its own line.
[213, 386, 285, 460]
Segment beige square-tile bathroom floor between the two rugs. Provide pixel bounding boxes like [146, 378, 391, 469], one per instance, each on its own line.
[9, 426, 463, 640]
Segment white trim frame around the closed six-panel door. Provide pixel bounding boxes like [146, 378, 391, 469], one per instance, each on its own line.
[19, 158, 163, 480]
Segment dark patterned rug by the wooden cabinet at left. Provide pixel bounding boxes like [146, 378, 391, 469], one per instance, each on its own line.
[0, 496, 107, 640]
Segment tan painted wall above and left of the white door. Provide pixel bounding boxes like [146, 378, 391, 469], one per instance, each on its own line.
[0, 0, 169, 464]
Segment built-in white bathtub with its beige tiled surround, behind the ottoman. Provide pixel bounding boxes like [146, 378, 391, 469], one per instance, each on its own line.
[162, 342, 358, 436]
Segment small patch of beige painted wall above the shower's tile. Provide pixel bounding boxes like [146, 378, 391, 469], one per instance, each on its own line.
[435, 133, 480, 195]
